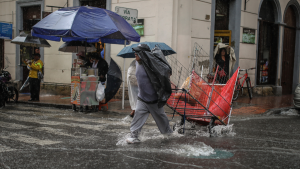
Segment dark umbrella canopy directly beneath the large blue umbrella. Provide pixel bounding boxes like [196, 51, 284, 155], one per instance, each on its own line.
[58, 41, 97, 53]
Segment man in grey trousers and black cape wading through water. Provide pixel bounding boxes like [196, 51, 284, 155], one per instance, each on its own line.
[126, 44, 173, 144]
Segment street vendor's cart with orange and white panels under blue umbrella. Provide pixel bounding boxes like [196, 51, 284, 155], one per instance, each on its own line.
[71, 67, 100, 111]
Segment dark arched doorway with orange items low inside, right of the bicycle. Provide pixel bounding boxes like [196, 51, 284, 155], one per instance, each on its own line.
[256, 0, 279, 85]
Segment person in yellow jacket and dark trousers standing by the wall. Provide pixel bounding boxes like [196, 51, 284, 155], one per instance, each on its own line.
[27, 53, 44, 101]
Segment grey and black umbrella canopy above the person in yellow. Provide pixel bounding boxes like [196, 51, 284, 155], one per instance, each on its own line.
[11, 32, 51, 47]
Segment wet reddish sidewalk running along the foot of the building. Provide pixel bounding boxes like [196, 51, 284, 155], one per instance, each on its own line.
[19, 94, 293, 115]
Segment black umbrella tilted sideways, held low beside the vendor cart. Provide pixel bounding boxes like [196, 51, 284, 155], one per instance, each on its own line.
[105, 59, 123, 103]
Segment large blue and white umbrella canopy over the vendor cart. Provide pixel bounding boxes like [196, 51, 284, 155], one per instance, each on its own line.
[32, 6, 140, 44]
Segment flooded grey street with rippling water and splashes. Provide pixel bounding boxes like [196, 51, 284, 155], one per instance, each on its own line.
[0, 105, 300, 169]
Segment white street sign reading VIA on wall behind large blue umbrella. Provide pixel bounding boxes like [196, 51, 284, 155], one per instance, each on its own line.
[115, 6, 138, 25]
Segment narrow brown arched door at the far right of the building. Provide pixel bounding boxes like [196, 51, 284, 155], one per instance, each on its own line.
[281, 6, 296, 94]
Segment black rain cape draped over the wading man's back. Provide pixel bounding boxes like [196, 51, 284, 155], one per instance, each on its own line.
[138, 48, 172, 108]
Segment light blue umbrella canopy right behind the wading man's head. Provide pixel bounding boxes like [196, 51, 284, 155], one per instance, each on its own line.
[118, 42, 176, 58]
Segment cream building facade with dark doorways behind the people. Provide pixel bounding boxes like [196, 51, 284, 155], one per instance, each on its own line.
[0, 0, 300, 94]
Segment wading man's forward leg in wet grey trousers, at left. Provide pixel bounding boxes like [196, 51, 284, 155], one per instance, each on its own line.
[130, 100, 149, 138]
